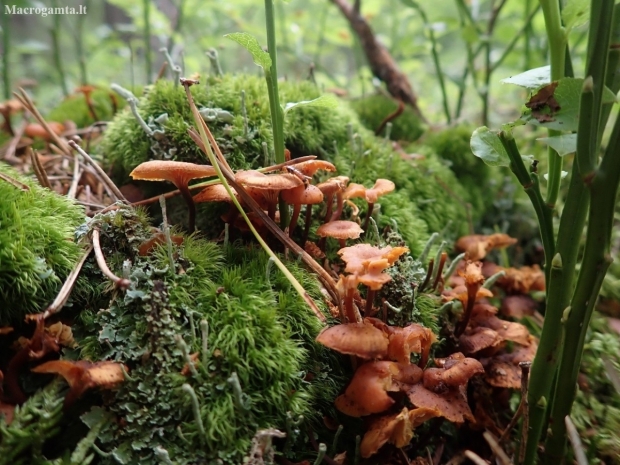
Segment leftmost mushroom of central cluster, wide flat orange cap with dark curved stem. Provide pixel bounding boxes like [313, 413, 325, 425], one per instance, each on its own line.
[129, 160, 217, 233]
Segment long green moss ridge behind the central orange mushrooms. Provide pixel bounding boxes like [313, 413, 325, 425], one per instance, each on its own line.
[101, 75, 467, 255]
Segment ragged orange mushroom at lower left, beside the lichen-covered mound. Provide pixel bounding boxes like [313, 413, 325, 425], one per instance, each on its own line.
[32, 360, 125, 408]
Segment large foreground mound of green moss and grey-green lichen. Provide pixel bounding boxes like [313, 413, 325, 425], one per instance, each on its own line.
[74, 208, 345, 464]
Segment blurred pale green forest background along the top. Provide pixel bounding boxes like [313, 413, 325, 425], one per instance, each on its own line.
[2, 0, 586, 126]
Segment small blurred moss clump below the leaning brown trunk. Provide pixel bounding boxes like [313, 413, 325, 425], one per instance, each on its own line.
[351, 94, 424, 142]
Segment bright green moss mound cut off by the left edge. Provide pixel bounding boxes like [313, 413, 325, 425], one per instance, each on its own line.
[0, 163, 85, 324]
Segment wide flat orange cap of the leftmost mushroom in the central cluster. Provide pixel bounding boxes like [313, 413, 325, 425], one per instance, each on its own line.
[129, 160, 217, 187]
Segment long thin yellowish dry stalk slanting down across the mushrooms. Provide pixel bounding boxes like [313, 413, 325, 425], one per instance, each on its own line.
[182, 80, 324, 319]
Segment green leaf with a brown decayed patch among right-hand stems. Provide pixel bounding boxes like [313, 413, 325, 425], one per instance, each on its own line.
[521, 78, 616, 131]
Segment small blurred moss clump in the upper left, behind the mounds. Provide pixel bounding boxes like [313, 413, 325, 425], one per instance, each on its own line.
[46, 89, 125, 128]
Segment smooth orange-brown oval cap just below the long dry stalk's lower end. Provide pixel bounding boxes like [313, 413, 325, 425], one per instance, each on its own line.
[316, 321, 388, 359]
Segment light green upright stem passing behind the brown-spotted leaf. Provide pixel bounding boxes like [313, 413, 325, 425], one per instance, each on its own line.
[540, 0, 566, 208]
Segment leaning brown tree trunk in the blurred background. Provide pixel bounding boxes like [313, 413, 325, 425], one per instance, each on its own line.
[331, 0, 427, 122]
